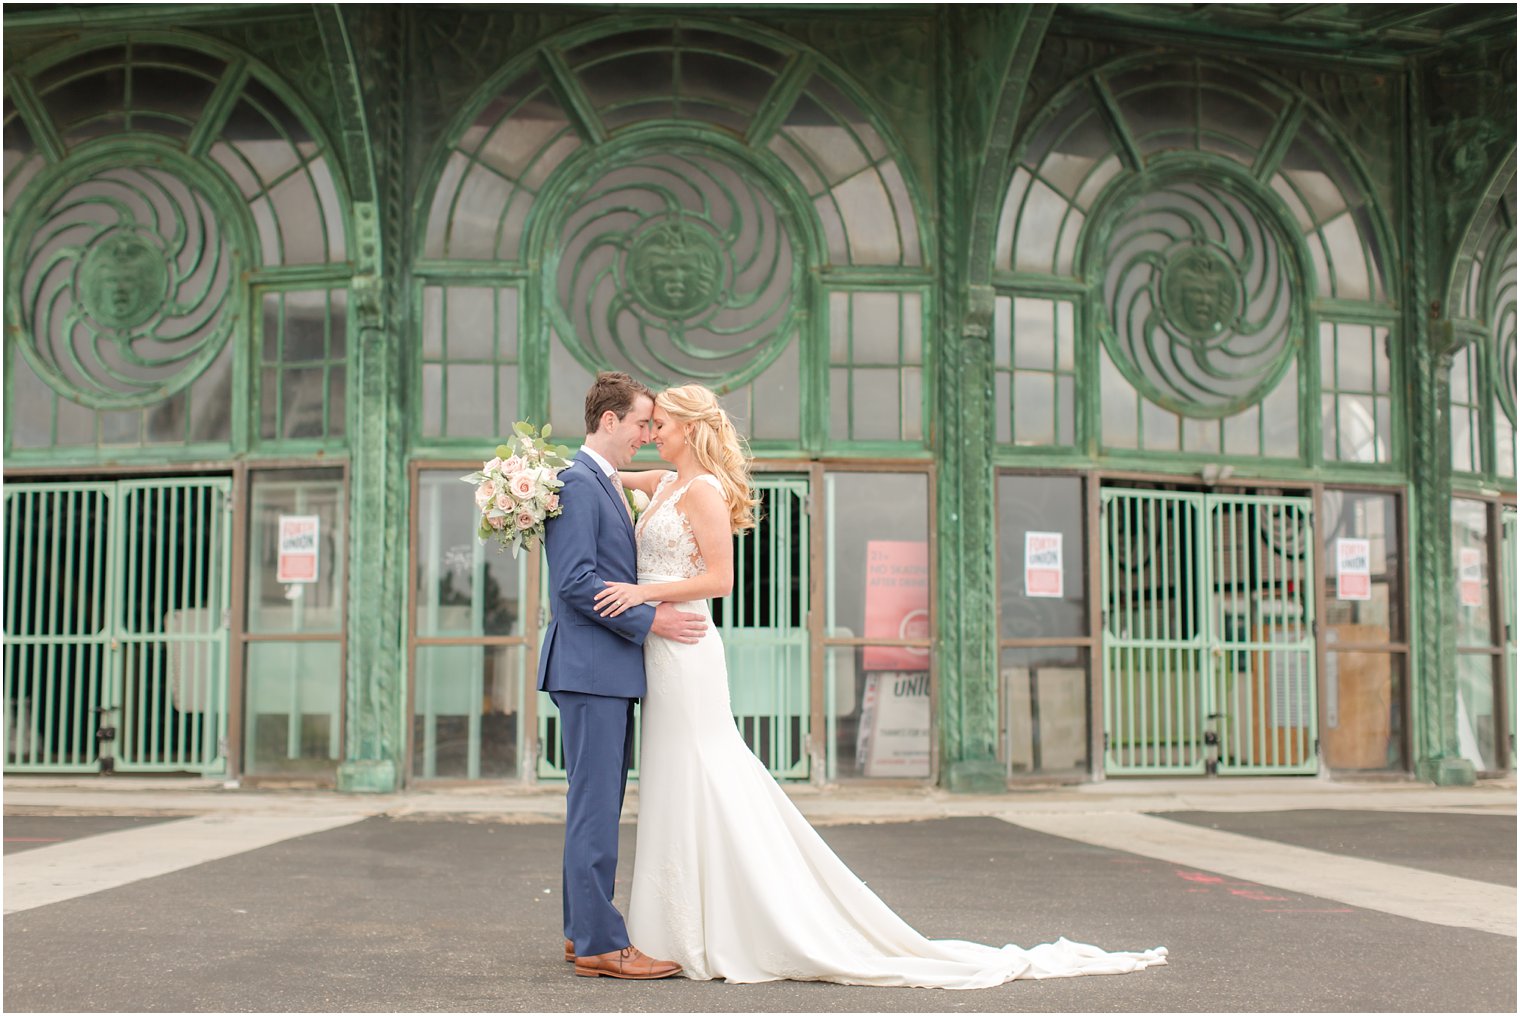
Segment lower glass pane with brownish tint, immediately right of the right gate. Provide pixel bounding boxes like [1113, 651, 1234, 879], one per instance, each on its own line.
[1324, 650, 1404, 770]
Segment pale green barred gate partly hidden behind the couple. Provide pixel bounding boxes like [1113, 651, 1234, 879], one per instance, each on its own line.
[538, 475, 812, 780]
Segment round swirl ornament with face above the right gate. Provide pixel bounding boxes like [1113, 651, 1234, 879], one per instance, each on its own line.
[1102, 176, 1304, 418]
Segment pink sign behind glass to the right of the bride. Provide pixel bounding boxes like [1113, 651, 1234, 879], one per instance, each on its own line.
[862, 540, 929, 671]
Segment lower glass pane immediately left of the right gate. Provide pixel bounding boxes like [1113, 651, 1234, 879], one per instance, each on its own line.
[999, 648, 1090, 776]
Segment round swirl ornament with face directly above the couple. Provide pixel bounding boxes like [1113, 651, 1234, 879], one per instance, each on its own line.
[546, 143, 803, 391]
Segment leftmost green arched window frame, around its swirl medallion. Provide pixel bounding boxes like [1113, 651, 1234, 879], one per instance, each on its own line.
[3, 29, 353, 464]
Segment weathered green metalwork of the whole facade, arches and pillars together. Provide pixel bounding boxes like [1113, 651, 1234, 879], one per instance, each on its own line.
[5, 5, 1515, 791]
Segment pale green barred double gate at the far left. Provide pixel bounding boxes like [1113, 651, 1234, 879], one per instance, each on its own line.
[5, 478, 231, 774]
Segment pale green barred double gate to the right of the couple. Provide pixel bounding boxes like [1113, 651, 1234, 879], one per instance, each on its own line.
[1100, 488, 1318, 776]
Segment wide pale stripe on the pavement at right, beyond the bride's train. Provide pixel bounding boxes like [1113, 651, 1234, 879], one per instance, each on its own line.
[999, 812, 1515, 938]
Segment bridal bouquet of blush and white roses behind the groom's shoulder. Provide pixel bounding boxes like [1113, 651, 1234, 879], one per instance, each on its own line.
[459, 420, 570, 557]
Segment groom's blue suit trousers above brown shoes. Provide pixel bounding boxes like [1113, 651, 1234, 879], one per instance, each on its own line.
[549, 692, 634, 957]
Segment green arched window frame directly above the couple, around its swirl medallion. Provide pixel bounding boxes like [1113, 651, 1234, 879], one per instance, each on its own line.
[413, 15, 933, 456]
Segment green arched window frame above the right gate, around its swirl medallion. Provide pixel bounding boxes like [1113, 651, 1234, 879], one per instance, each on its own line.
[993, 53, 1404, 475]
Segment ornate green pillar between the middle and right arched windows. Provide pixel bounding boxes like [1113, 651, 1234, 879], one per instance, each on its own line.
[933, 6, 1049, 792]
